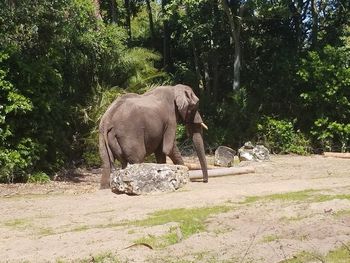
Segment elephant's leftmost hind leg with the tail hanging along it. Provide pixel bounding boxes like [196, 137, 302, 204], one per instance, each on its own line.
[99, 121, 114, 189]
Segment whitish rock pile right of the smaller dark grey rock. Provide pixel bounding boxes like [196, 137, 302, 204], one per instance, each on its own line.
[238, 142, 270, 161]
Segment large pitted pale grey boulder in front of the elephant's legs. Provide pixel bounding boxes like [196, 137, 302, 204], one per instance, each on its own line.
[111, 163, 189, 195]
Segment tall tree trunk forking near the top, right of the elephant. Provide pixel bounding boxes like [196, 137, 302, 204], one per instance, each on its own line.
[221, 0, 244, 90]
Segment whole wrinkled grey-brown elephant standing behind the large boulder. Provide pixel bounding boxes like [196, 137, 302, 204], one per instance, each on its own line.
[99, 85, 208, 189]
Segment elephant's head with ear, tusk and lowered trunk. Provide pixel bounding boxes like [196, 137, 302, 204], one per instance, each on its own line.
[174, 85, 208, 182]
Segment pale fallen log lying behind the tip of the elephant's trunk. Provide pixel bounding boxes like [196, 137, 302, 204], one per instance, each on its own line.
[189, 166, 255, 180]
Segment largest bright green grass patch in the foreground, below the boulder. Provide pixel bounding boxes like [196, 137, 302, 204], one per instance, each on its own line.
[129, 206, 232, 248]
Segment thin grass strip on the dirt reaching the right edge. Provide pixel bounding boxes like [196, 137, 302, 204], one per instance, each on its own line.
[240, 189, 350, 204]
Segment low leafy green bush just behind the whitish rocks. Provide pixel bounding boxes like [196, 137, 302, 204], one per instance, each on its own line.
[258, 117, 309, 154]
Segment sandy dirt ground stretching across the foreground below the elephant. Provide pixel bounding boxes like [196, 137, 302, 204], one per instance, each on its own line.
[0, 155, 350, 263]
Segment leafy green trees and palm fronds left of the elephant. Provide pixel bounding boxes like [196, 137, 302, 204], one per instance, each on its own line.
[0, 0, 161, 179]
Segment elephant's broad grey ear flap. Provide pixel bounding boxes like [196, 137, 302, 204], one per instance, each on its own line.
[175, 85, 199, 121]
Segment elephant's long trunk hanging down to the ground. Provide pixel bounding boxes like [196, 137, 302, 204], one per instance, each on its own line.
[190, 123, 208, 183]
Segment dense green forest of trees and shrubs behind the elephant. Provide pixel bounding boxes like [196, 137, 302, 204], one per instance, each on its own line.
[0, 0, 350, 182]
